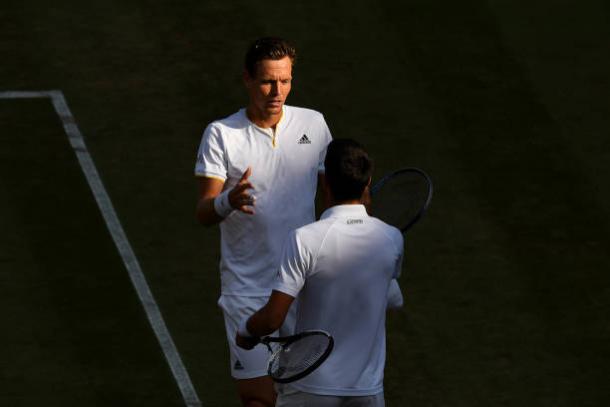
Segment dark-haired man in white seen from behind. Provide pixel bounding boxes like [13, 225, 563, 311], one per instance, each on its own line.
[236, 140, 403, 407]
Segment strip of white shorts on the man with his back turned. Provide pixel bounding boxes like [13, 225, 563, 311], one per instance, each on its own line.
[275, 384, 385, 407]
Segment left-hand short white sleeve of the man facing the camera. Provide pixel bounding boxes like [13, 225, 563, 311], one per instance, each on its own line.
[195, 123, 228, 180]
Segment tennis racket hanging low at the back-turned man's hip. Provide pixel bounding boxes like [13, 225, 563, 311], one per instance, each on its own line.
[261, 331, 334, 383]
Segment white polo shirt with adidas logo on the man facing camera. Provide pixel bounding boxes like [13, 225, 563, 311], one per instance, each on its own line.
[195, 106, 331, 296]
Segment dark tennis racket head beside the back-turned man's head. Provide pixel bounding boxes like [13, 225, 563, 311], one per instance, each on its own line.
[371, 167, 433, 233]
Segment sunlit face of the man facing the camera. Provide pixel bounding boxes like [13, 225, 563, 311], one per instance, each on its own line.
[244, 57, 292, 119]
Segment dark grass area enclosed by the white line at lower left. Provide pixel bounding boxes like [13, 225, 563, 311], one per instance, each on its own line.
[0, 99, 182, 406]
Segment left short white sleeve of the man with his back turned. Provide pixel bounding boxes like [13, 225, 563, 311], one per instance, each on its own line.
[273, 231, 311, 297]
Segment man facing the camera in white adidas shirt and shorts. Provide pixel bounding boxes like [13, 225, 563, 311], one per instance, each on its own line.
[195, 38, 331, 407]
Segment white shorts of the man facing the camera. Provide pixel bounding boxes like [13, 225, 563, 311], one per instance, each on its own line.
[218, 295, 296, 380]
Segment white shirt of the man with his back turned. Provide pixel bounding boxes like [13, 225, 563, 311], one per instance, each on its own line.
[273, 205, 403, 396]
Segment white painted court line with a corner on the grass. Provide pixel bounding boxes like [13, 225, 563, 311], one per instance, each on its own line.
[0, 90, 201, 407]
